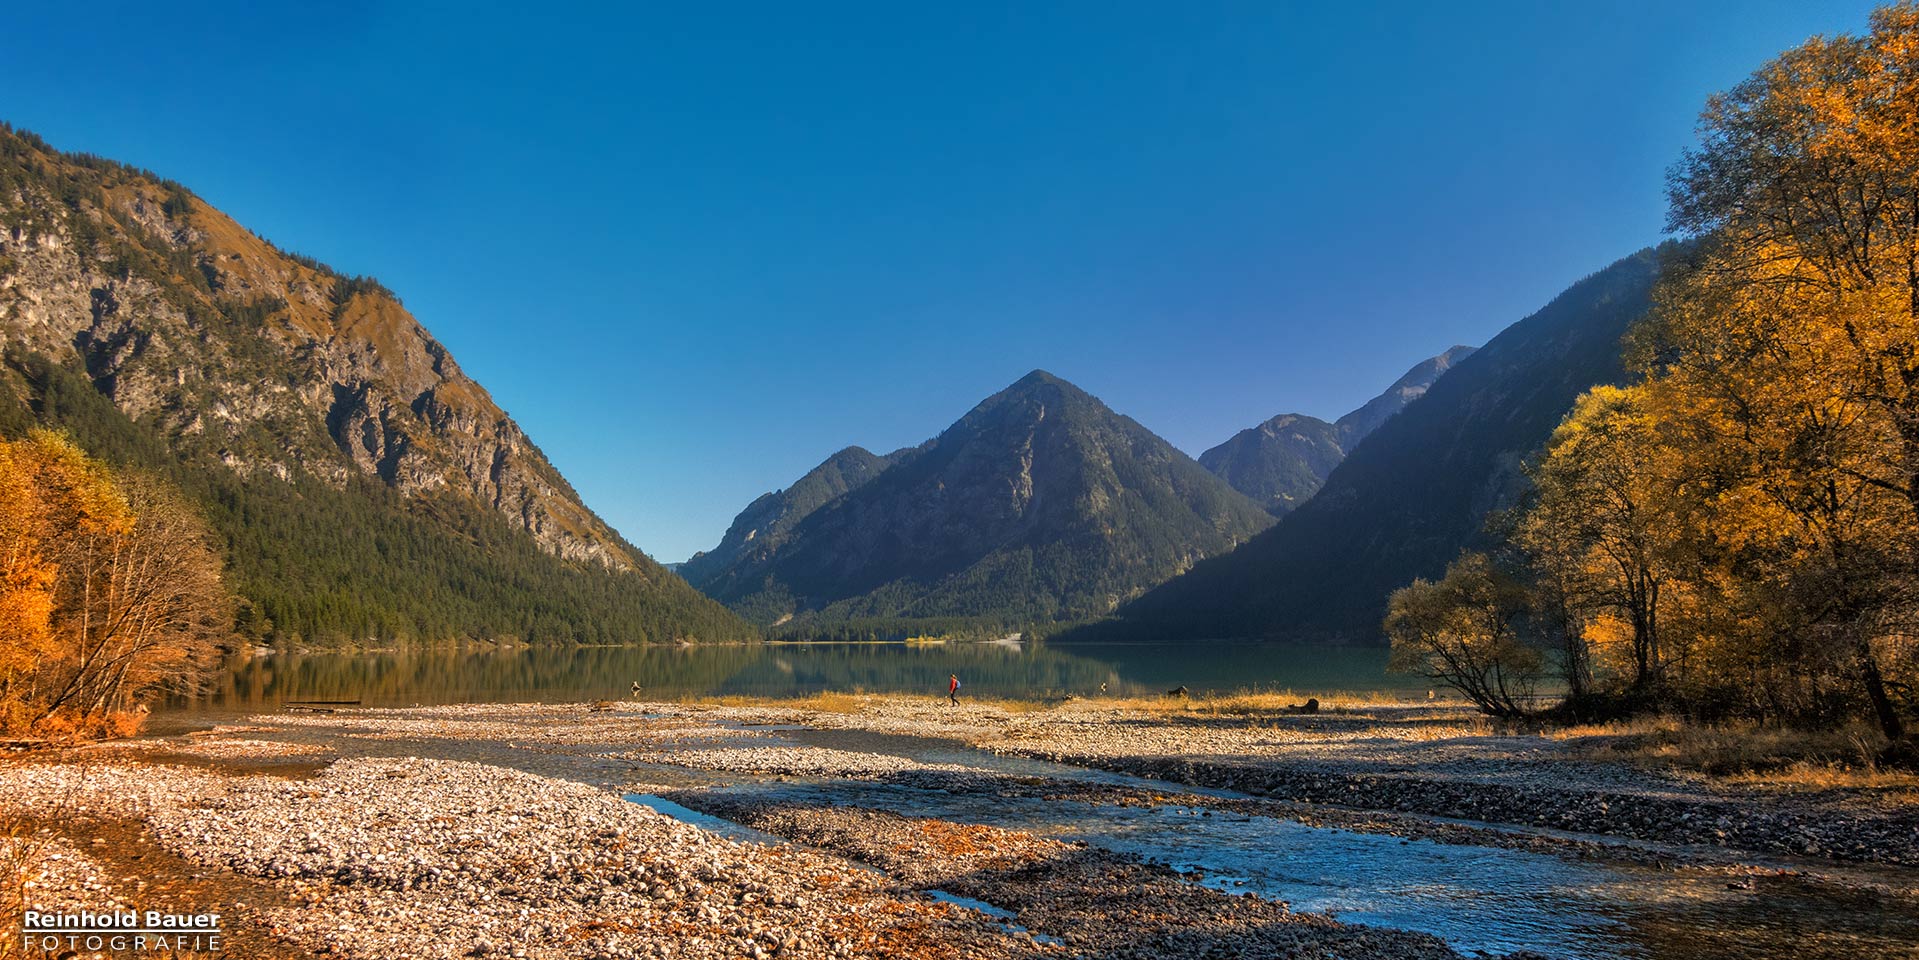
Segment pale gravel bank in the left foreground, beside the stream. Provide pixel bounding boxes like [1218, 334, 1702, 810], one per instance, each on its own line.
[0, 758, 1046, 958]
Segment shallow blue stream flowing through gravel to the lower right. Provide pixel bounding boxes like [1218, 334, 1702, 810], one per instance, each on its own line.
[635, 730, 1919, 960]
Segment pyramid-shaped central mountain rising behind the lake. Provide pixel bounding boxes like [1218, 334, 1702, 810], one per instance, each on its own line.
[700, 371, 1272, 624]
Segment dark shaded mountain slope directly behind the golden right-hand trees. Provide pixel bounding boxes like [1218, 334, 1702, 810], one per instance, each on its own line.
[1089, 250, 1660, 639]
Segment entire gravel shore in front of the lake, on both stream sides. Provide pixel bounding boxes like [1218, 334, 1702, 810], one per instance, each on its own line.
[0, 695, 1919, 960]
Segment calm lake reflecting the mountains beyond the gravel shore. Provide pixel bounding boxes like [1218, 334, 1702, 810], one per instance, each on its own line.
[173, 643, 1430, 710]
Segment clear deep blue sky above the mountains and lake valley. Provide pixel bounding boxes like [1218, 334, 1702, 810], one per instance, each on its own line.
[0, 0, 1871, 561]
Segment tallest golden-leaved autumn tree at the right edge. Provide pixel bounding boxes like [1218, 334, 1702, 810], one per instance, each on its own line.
[1635, 4, 1919, 741]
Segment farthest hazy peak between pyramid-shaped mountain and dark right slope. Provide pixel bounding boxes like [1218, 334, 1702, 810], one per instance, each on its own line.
[1199, 346, 1474, 516]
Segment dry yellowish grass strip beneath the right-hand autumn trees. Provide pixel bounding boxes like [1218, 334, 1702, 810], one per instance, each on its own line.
[1547, 716, 1919, 803]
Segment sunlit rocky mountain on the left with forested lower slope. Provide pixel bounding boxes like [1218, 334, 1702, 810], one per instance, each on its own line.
[0, 127, 752, 641]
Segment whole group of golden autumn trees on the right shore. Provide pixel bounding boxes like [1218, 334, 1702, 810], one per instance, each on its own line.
[1387, 2, 1919, 755]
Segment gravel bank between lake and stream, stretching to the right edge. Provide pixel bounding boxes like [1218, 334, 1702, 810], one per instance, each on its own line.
[671, 697, 1919, 866]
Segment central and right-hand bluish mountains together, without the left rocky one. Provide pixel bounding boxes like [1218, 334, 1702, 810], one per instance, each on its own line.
[683, 250, 1656, 641]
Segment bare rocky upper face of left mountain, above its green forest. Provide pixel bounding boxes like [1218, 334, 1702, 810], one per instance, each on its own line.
[0, 131, 637, 572]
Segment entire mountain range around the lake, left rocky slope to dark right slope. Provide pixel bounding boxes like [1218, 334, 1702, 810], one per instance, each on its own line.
[0, 127, 1656, 643]
